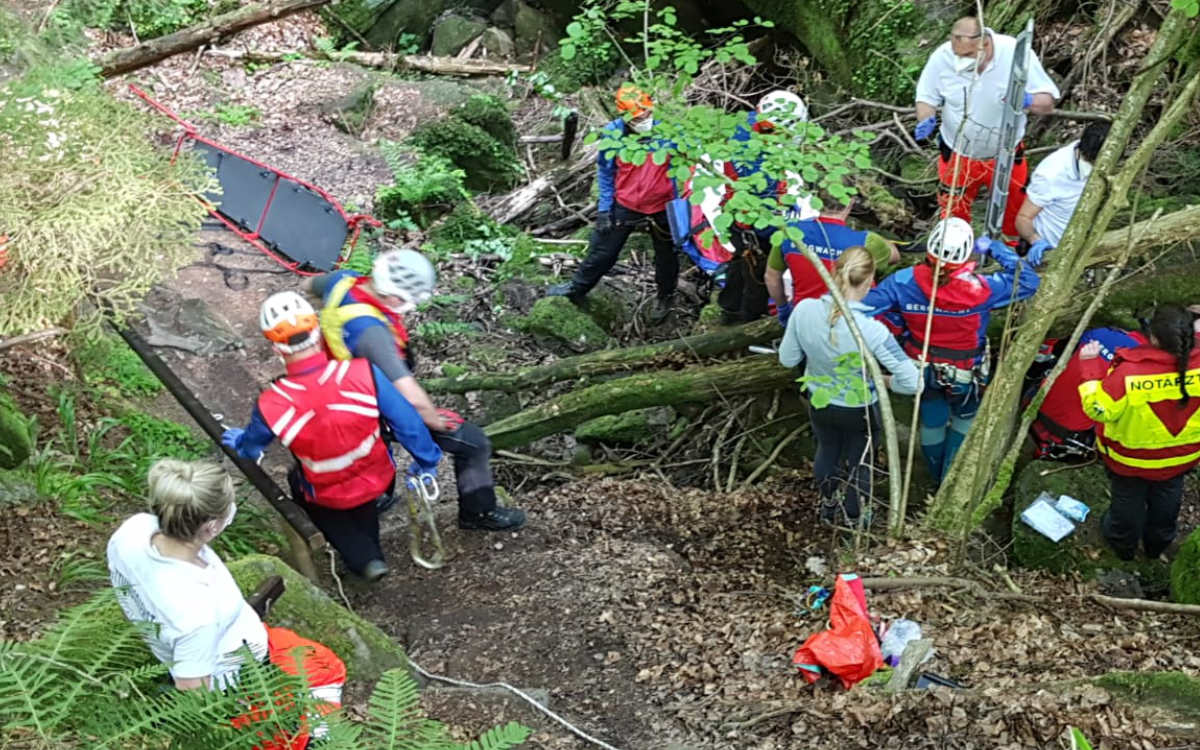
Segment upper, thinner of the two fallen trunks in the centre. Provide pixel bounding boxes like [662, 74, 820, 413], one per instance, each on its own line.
[424, 318, 781, 394]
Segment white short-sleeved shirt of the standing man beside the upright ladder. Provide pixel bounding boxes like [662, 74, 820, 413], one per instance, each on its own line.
[917, 31, 1061, 158]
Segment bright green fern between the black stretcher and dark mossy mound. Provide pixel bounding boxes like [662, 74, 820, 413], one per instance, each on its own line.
[374, 142, 467, 229]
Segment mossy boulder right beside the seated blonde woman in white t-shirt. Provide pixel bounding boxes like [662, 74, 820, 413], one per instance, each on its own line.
[228, 554, 408, 682]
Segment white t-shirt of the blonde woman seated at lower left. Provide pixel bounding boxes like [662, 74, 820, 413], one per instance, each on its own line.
[108, 514, 266, 688]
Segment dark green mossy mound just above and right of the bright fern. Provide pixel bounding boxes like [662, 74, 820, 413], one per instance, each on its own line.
[408, 115, 521, 191]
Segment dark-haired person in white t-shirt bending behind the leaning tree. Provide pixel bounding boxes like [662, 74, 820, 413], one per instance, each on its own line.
[1016, 120, 1111, 265]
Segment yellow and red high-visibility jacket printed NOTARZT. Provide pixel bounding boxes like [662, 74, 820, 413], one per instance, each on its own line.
[1079, 341, 1200, 480]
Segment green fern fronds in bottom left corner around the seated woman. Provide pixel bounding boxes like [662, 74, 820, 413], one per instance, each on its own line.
[0, 589, 529, 750]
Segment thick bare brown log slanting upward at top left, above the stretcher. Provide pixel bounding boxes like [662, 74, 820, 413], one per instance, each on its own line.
[96, 0, 329, 78]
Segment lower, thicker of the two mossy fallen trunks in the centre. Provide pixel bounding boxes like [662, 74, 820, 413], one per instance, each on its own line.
[484, 356, 796, 449]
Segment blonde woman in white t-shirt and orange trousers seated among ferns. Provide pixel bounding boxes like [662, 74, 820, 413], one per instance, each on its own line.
[106, 458, 346, 750]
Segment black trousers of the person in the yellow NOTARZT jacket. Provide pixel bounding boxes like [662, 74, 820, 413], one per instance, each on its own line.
[1103, 469, 1186, 560]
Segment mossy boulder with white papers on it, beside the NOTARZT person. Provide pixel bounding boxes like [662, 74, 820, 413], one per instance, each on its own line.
[1013, 461, 1169, 590]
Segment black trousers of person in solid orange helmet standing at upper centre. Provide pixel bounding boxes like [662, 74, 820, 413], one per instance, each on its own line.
[571, 203, 679, 299]
